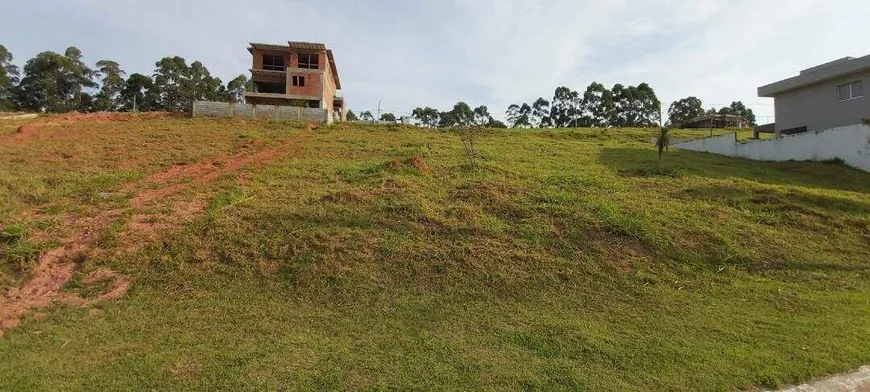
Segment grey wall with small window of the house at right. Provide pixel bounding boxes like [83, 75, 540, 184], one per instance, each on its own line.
[774, 70, 870, 134]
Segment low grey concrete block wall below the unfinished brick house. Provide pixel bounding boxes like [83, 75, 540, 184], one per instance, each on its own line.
[193, 101, 330, 123]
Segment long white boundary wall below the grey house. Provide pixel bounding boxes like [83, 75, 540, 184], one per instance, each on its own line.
[672, 124, 870, 172]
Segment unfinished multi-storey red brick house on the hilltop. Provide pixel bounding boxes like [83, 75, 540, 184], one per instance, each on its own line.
[245, 41, 347, 122]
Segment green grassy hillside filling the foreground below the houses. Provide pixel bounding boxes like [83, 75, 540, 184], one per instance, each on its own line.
[0, 116, 870, 390]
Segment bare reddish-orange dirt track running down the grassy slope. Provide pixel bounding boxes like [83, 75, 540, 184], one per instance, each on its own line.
[0, 135, 305, 337]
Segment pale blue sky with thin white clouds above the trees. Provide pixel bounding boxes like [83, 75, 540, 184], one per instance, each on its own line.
[0, 0, 870, 122]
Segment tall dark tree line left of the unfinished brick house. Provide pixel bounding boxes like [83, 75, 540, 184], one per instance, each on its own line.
[0, 45, 248, 113]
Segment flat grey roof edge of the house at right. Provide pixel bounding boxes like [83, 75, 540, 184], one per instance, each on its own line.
[758, 55, 870, 98]
